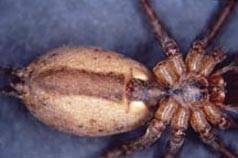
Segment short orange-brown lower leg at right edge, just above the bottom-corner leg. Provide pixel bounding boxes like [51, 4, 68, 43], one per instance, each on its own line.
[203, 102, 237, 129]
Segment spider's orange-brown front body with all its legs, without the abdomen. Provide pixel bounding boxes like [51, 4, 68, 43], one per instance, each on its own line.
[102, 0, 238, 158]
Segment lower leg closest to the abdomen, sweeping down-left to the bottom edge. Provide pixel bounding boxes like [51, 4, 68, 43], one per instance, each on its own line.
[101, 98, 177, 158]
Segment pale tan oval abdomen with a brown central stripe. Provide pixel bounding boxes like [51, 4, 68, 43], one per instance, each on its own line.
[19, 48, 150, 136]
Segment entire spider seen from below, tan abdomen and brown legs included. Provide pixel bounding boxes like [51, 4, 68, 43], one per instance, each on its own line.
[0, 0, 238, 158]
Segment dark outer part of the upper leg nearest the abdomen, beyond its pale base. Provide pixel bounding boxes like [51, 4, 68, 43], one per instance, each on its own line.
[140, 0, 180, 56]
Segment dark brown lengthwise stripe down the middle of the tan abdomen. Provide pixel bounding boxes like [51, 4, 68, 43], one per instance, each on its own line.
[34, 68, 126, 102]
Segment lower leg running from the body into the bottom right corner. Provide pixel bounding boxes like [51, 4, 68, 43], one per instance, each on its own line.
[190, 110, 236, 158]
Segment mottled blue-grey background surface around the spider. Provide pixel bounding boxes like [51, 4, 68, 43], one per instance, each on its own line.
[0, 0, 238, 158]
